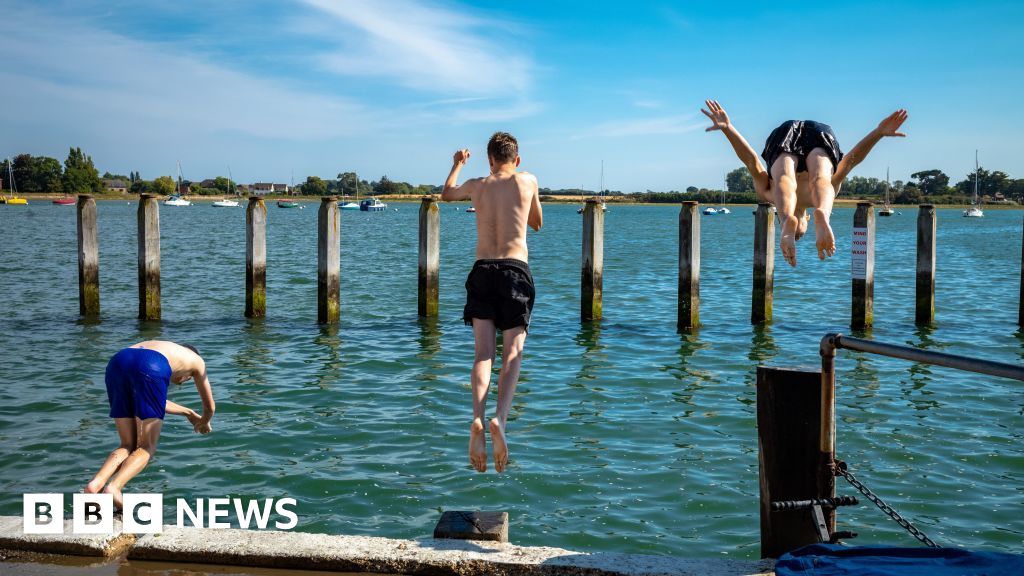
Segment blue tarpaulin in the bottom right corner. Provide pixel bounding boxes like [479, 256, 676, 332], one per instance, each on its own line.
[775, 544, 1024, 576]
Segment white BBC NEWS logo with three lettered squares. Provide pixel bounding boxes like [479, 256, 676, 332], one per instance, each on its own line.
[22, 494, 299, 534]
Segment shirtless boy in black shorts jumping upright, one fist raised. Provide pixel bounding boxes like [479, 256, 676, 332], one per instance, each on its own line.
[441, 132, 543, 472]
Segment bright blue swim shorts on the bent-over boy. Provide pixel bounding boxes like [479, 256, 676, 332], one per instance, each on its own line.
[106, 348, 171, 420]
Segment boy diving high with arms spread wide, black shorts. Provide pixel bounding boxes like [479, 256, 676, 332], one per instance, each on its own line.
[700, 100, 906, 266]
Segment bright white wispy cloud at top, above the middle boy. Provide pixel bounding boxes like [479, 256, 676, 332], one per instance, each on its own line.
[303, 0, 532, 102]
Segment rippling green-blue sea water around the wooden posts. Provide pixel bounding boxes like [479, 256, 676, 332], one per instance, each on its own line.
[0, 202, 1024, 558]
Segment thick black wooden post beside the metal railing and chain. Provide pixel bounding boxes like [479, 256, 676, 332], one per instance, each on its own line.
[757, 366, 836, 558]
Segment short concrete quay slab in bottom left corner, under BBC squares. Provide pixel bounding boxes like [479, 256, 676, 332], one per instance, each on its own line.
[0, 516, 135, 557]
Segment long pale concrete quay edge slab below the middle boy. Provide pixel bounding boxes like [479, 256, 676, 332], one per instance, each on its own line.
[128, 527, 773, 576]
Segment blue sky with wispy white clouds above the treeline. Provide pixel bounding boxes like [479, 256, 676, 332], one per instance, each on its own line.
[0, 0, 1024, 191]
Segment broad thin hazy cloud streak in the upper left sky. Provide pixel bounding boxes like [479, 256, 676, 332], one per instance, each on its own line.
[0, 3, 375, 139]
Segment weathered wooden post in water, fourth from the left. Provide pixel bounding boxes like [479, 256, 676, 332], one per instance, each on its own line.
[316, 196, 341, 324]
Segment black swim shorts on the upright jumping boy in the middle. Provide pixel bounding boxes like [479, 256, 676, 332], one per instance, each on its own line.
[462, 258, 537, 330]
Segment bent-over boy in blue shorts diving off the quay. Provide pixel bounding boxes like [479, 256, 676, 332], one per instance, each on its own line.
[85, 340, 216, 508]
